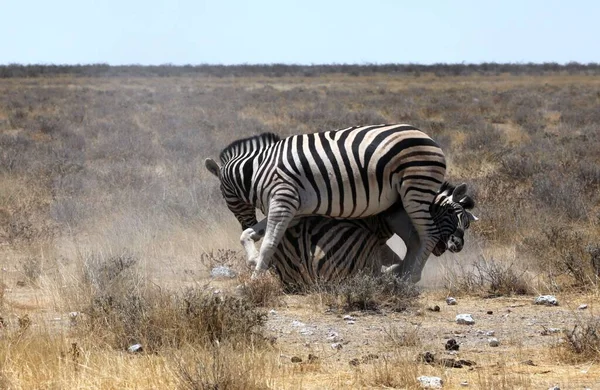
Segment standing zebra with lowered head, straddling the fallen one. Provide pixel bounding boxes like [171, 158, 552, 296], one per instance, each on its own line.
[205, 124, 472, 282]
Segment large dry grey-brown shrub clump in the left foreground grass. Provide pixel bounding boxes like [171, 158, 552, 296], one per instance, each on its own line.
[74, 253, 266, 351]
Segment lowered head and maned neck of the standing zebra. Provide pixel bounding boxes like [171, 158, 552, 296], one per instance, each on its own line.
[204, 133, 279, 230]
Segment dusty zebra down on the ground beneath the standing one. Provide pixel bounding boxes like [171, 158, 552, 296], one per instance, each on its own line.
[252, 183, 475, 291]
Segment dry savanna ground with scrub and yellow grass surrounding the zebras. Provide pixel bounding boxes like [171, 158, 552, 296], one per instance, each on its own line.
[0, 67, 600, 389]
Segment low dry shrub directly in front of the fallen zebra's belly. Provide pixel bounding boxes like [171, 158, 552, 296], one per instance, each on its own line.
[311, 272, 420, 312]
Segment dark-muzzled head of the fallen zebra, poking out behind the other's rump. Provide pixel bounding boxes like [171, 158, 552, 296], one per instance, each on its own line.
[432, 183, 479, 256]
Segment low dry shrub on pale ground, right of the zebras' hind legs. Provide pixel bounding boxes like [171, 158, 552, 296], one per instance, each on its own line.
[444, 256, 532, 296]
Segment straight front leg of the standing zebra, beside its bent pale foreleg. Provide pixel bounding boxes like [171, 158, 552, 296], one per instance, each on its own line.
[252, 194, 300, 279]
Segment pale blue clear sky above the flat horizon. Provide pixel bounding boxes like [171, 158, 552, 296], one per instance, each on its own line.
[0, 0, 600, 65]
